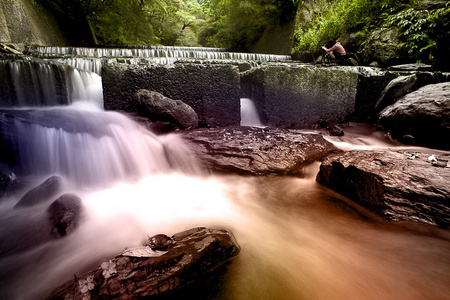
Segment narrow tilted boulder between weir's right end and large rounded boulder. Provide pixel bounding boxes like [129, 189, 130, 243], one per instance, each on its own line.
[375, 74, 417, 114]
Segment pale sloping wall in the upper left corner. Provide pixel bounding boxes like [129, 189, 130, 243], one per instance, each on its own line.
[0, 0, 67, 46]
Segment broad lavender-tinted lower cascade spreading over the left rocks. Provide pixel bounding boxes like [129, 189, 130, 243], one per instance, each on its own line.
[0, 103, 200, 187]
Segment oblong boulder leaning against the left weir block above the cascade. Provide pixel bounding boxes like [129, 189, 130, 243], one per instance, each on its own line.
[133, 90, 198, 129]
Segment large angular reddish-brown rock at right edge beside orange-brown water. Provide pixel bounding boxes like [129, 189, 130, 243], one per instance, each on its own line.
[317, 151, 450, 227]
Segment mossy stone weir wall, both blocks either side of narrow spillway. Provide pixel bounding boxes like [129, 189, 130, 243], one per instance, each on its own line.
[102, 59, 388, 128]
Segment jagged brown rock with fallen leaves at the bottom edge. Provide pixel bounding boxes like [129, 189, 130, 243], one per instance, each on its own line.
[48, 228, 240, 299]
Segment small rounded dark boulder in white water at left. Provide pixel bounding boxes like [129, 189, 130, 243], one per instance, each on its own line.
[47, 194, 82, 237]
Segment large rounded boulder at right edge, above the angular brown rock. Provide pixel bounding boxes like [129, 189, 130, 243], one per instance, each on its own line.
[378, 82, 450, 149]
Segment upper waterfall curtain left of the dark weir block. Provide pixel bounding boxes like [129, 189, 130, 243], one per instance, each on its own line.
[0, 59, 103, 107]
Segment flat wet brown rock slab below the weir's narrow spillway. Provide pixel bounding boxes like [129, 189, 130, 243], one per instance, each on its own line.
[185, 127, 339, 175]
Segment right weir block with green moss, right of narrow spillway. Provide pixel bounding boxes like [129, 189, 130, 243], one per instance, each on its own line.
[241, 65, 358, 128]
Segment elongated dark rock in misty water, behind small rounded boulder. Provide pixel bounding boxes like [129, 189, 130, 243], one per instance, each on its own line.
[14, 176, 62, 208]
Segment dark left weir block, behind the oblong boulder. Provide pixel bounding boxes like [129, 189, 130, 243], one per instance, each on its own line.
[102, 62, 240, 127]
